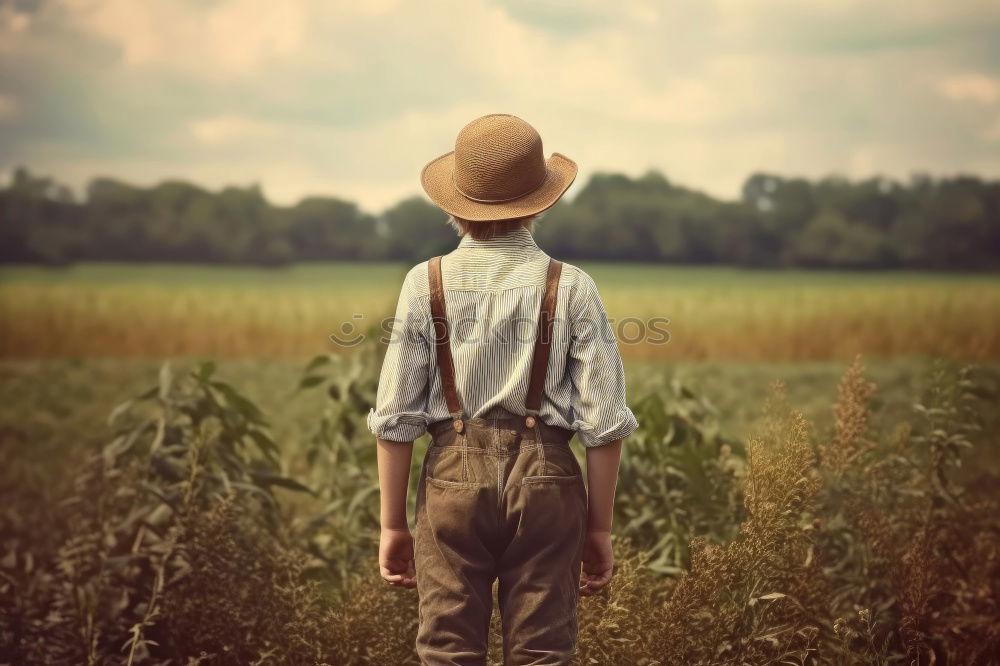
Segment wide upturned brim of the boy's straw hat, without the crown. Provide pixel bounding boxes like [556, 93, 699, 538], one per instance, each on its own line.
[420, 151, 577, 222]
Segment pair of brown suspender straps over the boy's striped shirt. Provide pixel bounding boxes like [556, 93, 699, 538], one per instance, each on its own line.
[427, 257, 562, 432]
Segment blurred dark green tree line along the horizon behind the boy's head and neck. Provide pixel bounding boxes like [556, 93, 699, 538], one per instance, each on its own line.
[0, 168, 1000, 270]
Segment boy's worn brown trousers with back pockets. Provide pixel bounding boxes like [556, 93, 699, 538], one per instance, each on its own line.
[414, 414, 587, 666]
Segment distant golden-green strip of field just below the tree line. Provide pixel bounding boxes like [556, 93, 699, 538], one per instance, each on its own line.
[0, 262, 1000, 361]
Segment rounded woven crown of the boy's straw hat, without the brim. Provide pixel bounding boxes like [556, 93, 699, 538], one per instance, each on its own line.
[454, 113, 546, 202]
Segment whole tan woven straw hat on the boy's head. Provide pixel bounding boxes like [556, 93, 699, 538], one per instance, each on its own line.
[420, 113, 576, 222]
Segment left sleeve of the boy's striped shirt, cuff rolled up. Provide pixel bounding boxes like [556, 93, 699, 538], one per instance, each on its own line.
[368, 266, 430, 442]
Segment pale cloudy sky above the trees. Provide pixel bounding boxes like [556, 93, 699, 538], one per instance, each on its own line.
[0, 0, 1000, 212]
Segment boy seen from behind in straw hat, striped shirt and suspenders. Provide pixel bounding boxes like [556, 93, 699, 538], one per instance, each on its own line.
[368, 114, 637, 666]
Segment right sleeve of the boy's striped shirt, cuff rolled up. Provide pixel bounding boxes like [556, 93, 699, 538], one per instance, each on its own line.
[567, 271, 639, 447]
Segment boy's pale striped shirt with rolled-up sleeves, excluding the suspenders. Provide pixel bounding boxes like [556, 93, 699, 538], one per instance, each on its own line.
[368, 223, 638, 447]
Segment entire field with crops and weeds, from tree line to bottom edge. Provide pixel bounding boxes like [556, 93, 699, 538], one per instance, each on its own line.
[0, 264, 1000, 666]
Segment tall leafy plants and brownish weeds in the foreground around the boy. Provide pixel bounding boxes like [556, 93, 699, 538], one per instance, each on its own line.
[0, 350, 1000, 666]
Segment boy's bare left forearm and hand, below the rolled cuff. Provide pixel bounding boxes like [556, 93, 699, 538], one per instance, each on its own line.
[377, 438, 417, 587]
